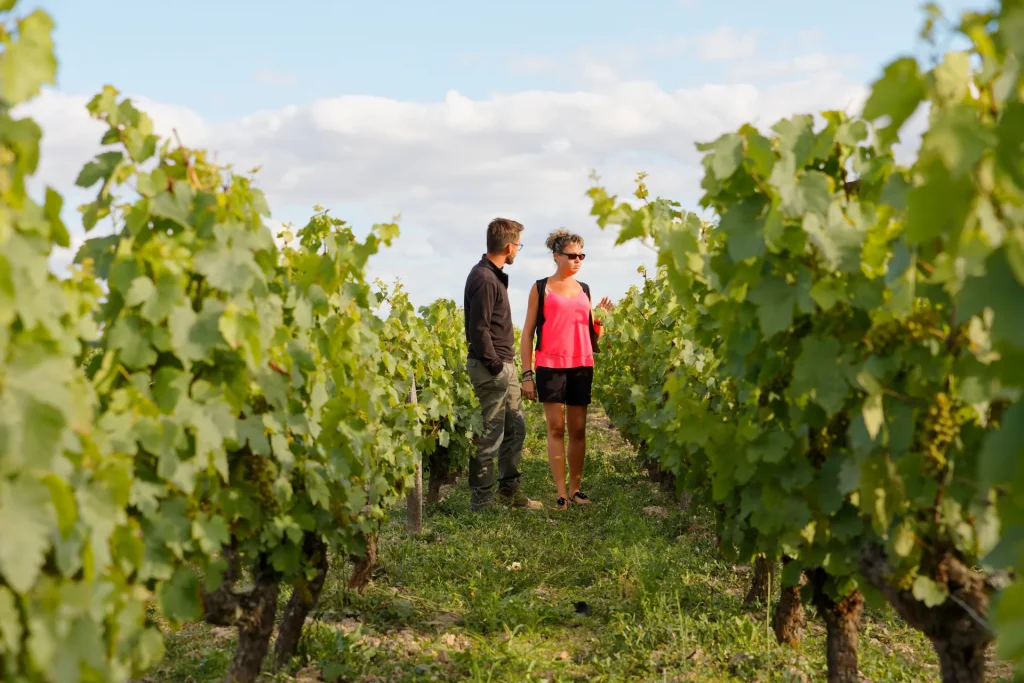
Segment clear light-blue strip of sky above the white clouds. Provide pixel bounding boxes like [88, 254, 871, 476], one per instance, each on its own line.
[38, 0, 964, 120]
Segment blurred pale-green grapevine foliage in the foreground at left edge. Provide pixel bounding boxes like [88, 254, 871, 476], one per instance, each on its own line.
[0, 2, 163, 681]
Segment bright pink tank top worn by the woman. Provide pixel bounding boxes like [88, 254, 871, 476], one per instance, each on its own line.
[536, 288, 594, 369]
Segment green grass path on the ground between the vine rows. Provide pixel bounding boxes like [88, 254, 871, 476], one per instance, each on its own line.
[147, 404, 999, 682]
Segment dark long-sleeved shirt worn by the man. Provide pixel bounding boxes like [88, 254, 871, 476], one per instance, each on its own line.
[463, 255, 515, 375]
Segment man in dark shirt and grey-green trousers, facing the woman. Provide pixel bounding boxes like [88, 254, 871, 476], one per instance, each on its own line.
[463, 218, 542, 511]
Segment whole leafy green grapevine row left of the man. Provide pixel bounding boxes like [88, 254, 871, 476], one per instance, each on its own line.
[0, 3, 475, 681]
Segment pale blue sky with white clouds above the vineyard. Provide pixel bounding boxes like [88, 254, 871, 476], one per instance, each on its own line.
[17, 0, 987, 325]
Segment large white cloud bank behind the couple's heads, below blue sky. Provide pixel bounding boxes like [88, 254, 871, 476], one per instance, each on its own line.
[16, 48, 909, 322]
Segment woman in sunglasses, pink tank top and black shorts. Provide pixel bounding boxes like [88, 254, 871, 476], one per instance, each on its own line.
[519, 229, 612, 510]
